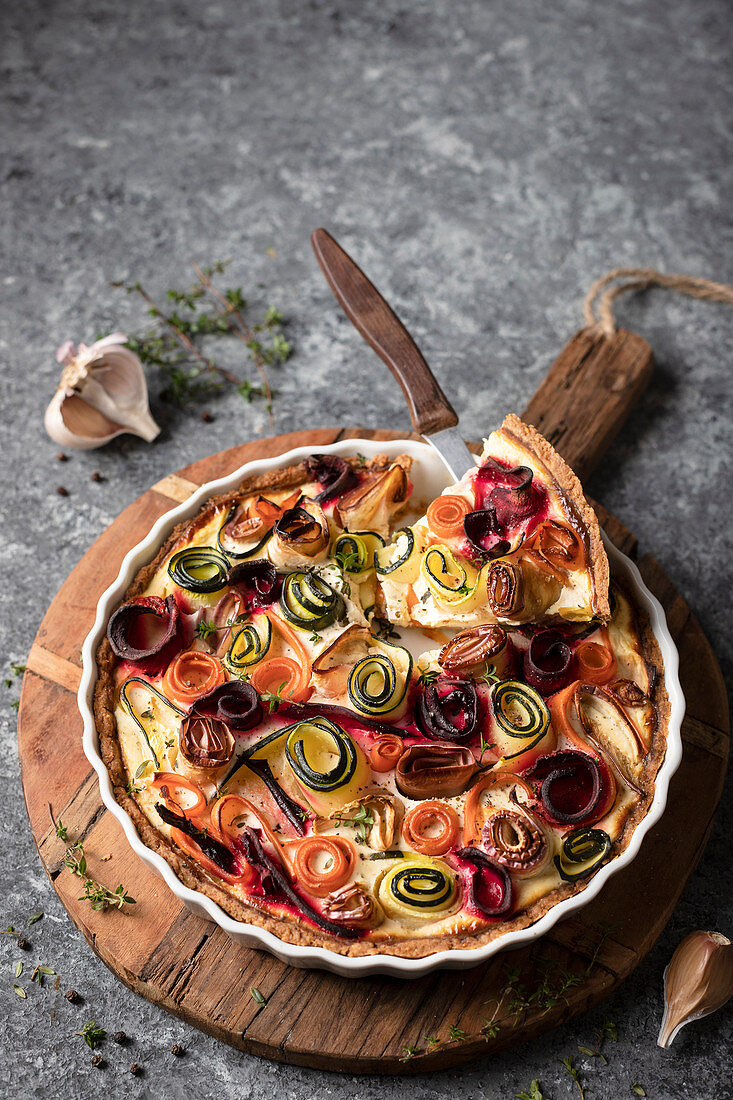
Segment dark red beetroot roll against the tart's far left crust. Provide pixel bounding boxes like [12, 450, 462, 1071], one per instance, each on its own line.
[107, 596, 183, 672]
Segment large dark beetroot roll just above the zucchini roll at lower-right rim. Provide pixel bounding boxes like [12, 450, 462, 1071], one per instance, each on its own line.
[523, 749, 604, 825]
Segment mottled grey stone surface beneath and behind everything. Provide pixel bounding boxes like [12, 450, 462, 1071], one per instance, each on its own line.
[0, 0, 733, 1100]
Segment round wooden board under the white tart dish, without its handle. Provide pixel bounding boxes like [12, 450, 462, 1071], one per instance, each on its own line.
[19, 428, 729, 1074]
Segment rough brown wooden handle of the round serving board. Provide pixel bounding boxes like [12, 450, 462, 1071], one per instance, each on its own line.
[522, 328, 654, 481]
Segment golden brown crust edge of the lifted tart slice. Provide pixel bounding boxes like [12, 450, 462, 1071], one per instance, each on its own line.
[499, 413, 611, 622]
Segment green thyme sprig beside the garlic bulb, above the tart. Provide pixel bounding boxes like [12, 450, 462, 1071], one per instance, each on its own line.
[110, 261, 292, 422]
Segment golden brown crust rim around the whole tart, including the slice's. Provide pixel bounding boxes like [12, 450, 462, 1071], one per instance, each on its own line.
[94, 444, 669, 958]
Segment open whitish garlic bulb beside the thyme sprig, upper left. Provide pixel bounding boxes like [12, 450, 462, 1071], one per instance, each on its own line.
[43, 332, 161, 451]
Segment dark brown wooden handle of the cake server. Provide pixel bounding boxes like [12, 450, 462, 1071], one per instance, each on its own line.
[310, 229, 458, 436]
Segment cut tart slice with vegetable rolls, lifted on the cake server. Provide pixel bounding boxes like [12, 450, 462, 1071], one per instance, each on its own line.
[376, 415, 609, 629]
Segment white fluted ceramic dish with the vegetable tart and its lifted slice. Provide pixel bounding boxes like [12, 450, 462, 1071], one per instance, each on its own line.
[79, 417, 683, 977]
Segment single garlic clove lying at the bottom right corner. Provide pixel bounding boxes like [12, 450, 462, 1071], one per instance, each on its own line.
[657, 932, 733, 1046]
